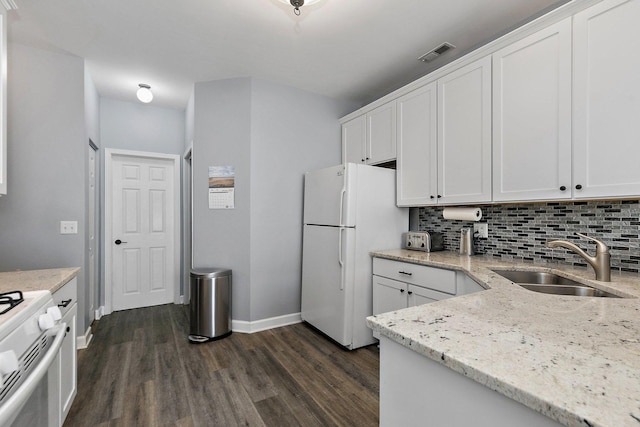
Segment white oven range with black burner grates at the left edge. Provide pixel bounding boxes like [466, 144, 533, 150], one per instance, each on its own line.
[0, 291, 66, 427]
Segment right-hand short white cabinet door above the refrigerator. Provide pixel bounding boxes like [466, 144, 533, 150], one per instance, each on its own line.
[365, 100, 396, 164]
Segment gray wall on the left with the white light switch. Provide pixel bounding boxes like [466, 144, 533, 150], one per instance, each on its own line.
[0, 43, 86, 332]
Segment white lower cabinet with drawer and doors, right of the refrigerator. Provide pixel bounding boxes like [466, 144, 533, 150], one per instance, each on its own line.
[373, 258, 484, 338]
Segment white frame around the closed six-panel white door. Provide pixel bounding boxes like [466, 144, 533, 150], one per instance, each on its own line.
[103, 148, 182, 314]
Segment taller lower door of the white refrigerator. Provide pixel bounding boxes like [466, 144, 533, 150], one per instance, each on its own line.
[301, 225, 355, 348]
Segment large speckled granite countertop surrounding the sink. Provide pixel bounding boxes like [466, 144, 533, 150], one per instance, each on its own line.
[367, 250, 640, 427]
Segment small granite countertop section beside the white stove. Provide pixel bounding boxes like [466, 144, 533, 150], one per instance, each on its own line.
[0, 267, 80, 294]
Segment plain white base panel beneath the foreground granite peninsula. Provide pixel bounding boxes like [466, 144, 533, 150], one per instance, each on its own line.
[380, 336, 561, 427]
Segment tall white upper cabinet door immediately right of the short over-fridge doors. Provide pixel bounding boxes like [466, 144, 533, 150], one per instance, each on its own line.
[396, 82, 438, 206]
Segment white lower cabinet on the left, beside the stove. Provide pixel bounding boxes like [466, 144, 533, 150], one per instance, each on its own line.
[53, 278, 78, 425]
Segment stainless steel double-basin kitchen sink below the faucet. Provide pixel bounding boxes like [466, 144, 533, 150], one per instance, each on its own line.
[493, 270, 620, 298]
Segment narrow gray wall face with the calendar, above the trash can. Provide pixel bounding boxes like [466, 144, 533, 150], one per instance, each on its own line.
[192, 79, 251, 320]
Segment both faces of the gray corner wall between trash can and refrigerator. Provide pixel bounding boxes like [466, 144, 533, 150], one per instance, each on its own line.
[193, 78, 357, 321]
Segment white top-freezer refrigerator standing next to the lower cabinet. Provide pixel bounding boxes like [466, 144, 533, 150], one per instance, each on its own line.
[301, 163, 409, 349]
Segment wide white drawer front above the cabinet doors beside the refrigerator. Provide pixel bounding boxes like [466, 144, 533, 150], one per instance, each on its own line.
[373, 258, 456, 295]
